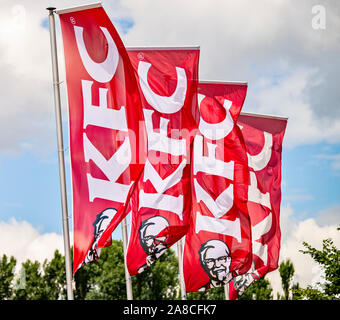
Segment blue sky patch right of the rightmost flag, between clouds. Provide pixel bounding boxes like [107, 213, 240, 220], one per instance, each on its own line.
[282, 144, 340, 219]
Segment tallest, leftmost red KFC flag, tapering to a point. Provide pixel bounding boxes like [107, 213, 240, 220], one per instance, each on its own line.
[58, 5, 144, 272]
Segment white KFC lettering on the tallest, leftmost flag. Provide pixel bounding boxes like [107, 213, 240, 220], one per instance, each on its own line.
[74, 26, 133, 202]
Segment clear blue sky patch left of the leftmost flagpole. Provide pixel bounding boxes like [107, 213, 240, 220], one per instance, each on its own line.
[0, 153, 65, 233]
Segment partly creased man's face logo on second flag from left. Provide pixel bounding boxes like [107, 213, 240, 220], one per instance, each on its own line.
[139, 216, 169, 265]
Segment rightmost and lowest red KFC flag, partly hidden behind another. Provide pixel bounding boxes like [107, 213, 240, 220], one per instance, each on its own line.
[229, 114, 287, 299]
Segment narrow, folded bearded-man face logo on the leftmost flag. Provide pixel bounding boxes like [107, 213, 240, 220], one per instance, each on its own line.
[83, 208, 117, 264]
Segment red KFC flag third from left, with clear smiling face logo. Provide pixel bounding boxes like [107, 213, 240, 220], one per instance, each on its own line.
[183, 83, 251, 292]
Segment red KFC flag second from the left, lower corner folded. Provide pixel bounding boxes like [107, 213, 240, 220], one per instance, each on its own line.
[126, 48, 199, 275]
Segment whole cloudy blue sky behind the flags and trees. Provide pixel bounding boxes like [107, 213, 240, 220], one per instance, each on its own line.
[0, 0, 340, 296]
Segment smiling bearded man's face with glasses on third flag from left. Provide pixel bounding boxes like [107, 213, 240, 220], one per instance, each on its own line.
[198, 240, 231, 288]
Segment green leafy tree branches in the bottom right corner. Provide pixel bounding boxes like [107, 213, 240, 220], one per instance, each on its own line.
[295, 227, 340, 300]
